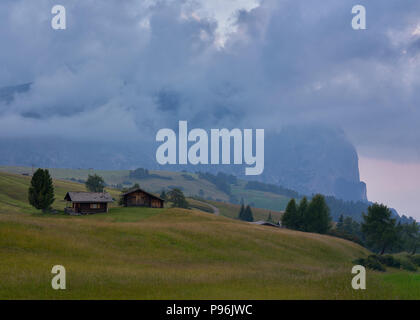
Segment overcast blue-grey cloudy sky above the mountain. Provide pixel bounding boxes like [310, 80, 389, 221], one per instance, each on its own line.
[0, 0, 420, 218]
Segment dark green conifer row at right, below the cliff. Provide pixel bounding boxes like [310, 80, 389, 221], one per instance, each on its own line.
[282, 194, 420, 255]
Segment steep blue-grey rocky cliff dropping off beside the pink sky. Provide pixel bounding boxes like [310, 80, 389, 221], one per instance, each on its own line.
[261, 126, 367, 200]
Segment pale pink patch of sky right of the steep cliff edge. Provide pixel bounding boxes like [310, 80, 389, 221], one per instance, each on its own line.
[359, 157, 420, 221]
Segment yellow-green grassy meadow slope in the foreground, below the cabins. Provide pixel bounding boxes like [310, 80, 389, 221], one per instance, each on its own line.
[0, 173, 420, 299]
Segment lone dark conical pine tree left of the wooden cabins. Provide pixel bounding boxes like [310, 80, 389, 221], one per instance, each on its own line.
[28, 169, 55, 212]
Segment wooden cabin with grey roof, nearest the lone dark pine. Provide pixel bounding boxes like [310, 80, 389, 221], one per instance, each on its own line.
[64, 192, 114, 214]
